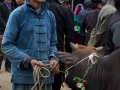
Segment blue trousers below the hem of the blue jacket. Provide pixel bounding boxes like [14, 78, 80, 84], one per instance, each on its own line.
[12, 83, 52, 90]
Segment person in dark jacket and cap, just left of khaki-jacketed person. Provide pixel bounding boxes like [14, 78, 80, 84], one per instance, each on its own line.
[80, 0, 107, 46]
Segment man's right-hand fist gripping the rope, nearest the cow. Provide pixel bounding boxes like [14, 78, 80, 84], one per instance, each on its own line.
[50, 60, 60, 74]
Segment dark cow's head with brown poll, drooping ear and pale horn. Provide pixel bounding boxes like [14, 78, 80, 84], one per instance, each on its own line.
[55, 43, 97, 90]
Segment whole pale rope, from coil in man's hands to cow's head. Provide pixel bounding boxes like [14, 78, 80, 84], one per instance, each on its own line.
[31, 53, 98, 90]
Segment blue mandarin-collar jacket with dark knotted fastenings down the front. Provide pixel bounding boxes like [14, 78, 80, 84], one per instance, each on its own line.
[2, 3, 57, 84]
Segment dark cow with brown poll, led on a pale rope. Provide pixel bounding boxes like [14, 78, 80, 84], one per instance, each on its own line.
[55, 43, 120, 90]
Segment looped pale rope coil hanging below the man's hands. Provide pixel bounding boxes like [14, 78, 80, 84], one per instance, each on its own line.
[31, 61, 50, 90]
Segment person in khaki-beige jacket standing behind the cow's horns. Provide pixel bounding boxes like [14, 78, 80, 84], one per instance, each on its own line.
[88, 0, 116, 55]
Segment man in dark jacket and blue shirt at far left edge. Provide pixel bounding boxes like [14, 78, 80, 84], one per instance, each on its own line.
[0, 0, 15, 72]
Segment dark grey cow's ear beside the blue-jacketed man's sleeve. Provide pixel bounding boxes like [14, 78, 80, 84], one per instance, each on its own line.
[55, 51, 74, 64]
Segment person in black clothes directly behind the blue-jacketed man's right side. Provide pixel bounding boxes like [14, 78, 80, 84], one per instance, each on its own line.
[49, 0, 74, 90]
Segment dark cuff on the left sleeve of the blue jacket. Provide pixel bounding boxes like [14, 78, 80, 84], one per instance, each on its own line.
[21, 55, 33, 69]
